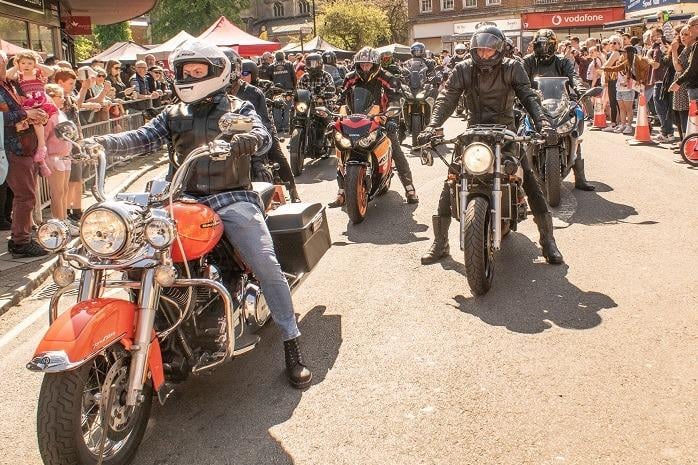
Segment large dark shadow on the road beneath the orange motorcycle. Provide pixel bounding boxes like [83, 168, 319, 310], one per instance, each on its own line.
[133, 306, 342, 465]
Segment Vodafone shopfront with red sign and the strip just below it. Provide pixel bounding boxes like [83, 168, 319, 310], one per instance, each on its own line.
[521, 7, 625, 50]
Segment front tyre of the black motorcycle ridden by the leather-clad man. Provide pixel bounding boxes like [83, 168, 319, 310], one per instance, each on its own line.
[461, 197, 494, 295]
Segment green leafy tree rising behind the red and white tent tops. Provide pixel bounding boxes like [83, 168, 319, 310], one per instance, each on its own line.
[150, 0, 250, 42]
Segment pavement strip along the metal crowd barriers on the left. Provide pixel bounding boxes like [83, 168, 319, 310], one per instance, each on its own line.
[0, 153, 167, 315]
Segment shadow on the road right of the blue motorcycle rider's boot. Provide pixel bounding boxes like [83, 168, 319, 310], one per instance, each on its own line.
[568, 182, 657, 226]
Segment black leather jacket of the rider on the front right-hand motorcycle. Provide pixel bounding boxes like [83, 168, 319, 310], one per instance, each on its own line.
[429, 58, 543, 130]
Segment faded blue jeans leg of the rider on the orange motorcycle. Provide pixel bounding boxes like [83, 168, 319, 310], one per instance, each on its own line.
[217, 202, 301, 341]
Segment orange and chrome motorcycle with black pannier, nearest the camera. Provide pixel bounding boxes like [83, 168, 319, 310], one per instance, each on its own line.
[27, 114, 330, 465]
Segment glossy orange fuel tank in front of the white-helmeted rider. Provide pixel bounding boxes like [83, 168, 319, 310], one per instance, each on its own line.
[172, 201, 223, 263]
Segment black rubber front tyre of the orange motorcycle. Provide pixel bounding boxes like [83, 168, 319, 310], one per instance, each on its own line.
[37, 351, 153, 465]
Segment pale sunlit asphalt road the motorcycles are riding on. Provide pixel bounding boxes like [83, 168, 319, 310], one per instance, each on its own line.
[0, 119, 698, 465]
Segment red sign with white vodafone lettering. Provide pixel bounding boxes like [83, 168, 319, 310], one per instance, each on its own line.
[521, 6, 625, 31]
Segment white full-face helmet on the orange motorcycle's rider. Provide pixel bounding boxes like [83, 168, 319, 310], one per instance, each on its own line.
[169, 39, 232, 103]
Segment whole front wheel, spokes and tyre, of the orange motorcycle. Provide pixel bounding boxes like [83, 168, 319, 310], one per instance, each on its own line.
[37, 350, 153, 465]
